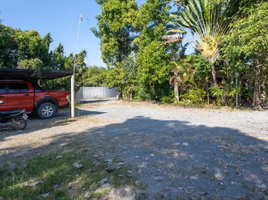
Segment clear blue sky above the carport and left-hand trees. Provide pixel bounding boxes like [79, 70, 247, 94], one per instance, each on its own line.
[0, 0, 193, 66]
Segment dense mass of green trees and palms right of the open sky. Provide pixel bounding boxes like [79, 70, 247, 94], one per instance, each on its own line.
[94, 0, 268, 108]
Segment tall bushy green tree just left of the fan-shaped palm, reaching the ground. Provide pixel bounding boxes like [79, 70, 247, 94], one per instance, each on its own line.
[133, 0, 177, 100]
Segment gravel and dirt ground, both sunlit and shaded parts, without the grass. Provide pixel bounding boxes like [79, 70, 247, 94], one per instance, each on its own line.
[0, 101, 268, 199]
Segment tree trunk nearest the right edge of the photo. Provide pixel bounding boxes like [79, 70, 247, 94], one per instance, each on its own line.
[253, 61, 261, 109]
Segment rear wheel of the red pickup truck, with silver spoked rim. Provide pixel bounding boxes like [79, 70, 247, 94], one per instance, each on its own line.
[37, 102, 57, 119]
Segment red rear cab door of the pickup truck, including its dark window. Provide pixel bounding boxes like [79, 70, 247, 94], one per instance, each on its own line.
[6, 82, 34, 112]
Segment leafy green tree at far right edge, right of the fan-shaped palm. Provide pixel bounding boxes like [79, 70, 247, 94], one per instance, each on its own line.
[223, 3, 268, 107]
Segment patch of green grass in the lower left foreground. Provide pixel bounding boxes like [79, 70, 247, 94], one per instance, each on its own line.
[0, 151, 137, 200]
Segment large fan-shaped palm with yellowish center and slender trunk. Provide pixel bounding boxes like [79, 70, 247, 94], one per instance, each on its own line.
[165, 0, 233, 85]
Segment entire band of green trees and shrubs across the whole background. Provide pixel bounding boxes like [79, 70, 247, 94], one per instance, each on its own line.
[0, 0, 268, 109]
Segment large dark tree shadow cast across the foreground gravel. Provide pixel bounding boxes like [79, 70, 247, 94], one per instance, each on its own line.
[0, 116, 268, 199]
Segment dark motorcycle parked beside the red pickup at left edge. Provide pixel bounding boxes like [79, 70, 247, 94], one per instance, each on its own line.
[0, 109, 28, 130]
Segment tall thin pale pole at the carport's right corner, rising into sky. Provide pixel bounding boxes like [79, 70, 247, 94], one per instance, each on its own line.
[71, 13, 84, 118]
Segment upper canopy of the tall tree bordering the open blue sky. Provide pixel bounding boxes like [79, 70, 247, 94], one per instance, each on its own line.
[91, 0, 138, 66]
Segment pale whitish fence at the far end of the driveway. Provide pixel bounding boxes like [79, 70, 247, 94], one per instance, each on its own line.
[77, 87, 118, 100]
